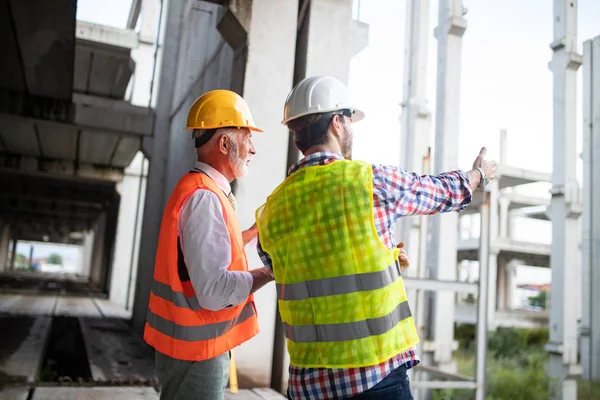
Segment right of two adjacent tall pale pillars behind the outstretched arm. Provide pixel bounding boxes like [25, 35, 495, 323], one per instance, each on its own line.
[430, 0, 466, 370]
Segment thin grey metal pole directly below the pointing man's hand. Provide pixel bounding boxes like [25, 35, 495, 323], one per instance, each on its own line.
[475, 192, 490, 400]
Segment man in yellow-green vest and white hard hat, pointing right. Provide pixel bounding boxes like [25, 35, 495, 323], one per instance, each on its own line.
[257, 77, 496, 400]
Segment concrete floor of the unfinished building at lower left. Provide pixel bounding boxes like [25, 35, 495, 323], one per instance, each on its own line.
[0, 274, 285, 400]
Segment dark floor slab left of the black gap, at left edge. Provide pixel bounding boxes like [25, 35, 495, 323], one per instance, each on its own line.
[0, 317, 52, 382]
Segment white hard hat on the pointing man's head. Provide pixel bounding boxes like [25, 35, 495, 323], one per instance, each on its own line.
[281, 76, 365, 125]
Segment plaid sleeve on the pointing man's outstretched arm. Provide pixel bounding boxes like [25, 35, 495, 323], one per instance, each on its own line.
[373, 165, 473, 217]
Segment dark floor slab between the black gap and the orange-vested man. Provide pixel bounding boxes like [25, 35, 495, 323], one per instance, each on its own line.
[79, 318, 158, 384]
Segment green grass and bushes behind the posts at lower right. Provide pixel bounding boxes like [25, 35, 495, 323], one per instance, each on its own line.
[432, 325, 600, 400]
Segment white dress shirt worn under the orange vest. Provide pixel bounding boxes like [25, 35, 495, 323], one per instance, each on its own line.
[178, 161, 253, 311]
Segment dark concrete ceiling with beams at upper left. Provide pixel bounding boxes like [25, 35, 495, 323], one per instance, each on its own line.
[0, 0, 148, 243]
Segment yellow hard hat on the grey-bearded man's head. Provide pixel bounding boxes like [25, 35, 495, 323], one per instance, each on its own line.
[185, 90, 262, 132]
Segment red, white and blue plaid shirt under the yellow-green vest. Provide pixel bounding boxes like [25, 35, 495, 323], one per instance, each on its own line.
[257, 152, 472, 400]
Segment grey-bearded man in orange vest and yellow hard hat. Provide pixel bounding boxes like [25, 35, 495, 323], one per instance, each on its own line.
[144, 90, 273, 399]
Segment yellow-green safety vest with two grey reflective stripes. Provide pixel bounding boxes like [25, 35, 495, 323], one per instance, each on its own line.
[256, 160, 419, 368]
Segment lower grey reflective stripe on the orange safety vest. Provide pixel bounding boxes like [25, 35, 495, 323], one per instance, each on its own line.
[146, 303, 254, 342]
